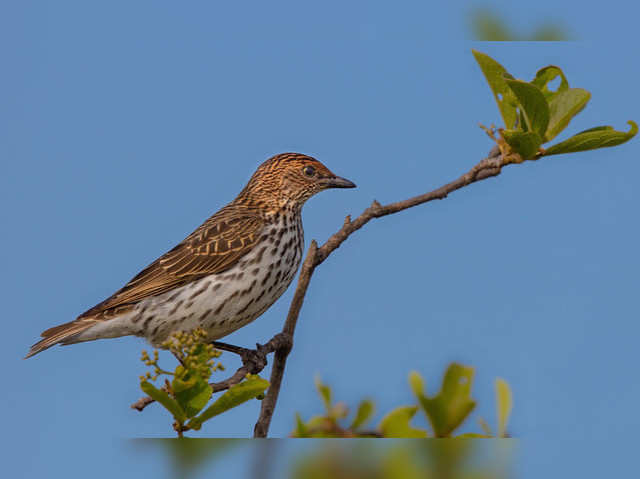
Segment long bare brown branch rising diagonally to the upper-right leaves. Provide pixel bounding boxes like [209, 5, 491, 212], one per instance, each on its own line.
[253, 144, 522, 437]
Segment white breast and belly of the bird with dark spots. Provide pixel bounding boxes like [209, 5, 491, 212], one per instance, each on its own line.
[127, 217, 302, 347]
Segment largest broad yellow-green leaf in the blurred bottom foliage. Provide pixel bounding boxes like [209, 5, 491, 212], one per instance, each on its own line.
[419, 363, 476, 437]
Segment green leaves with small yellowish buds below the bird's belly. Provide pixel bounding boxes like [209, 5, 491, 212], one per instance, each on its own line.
[140, 329, 269, 437]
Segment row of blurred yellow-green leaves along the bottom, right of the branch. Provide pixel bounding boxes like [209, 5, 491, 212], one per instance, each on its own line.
[292, 363, 513, 438]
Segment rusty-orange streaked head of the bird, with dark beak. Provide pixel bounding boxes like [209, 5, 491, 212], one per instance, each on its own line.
[240, 153, 356, 209]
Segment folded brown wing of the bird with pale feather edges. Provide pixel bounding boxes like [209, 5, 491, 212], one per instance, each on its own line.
[78, 207, 264, 319]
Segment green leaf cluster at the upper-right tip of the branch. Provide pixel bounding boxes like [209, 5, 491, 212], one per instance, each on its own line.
[473, 50, 638, 163]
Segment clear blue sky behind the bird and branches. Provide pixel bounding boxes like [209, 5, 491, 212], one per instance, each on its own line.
[0, 1, 640, 477]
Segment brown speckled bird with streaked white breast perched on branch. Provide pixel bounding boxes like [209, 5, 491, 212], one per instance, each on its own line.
[25, 153, 356, 359]
